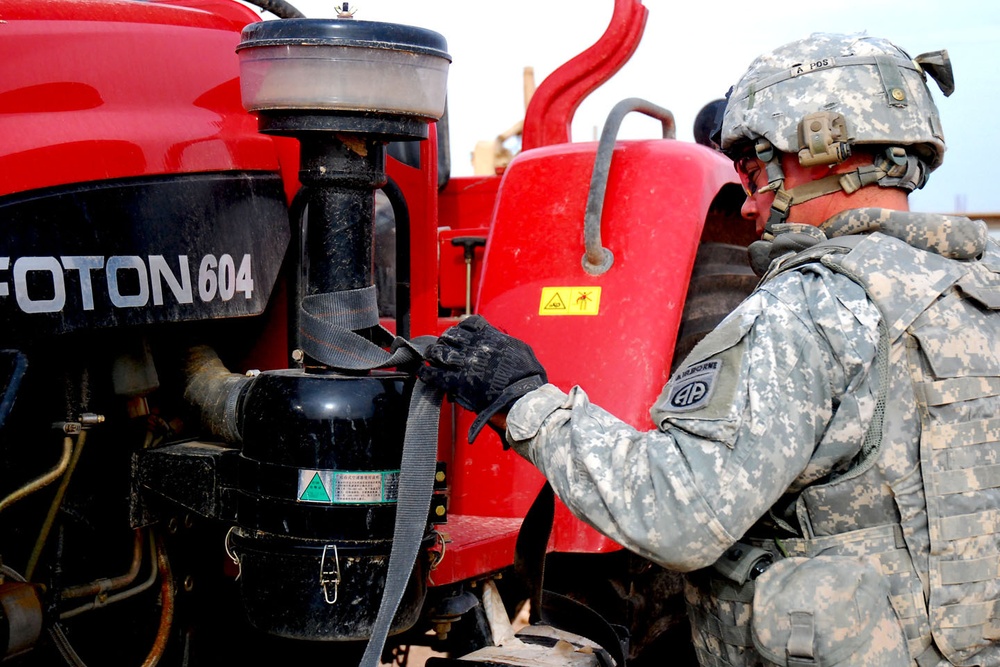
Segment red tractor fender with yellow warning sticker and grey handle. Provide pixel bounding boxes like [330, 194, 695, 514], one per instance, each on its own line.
[452, 140, 734, 551]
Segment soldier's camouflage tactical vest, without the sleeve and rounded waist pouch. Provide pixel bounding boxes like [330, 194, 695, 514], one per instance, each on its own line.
[687, 220, 1000, 667]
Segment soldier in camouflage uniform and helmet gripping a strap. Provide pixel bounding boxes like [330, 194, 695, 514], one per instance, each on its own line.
[421, 34, 1000, 667]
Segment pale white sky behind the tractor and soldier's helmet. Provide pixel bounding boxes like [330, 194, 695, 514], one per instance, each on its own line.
[280, 0, 1000, 213]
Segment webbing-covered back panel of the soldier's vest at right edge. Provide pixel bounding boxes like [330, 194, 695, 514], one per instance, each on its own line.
[907, 286, 1000, 664]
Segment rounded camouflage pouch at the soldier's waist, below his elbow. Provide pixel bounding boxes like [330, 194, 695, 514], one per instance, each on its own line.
[752, 556, 911, 667]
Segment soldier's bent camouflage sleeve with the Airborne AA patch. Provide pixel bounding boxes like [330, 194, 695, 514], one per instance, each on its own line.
[507, 266, 878, 571]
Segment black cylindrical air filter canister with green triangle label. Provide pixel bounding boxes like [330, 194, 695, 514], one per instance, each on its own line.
[228, 370, 427, 641]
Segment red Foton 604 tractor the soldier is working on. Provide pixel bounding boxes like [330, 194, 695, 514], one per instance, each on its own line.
[0, 0, 755, 666]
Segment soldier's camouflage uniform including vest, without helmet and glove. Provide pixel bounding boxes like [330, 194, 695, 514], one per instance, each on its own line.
[507, 209, 1000, 667]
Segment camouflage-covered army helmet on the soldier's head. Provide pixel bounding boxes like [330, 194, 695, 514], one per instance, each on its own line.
[719, 33, 954, 174]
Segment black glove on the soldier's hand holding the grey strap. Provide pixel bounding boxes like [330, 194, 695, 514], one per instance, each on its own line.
[417, 315, 548, 443]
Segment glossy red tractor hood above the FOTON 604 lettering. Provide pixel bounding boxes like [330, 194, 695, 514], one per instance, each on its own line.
[0, 0, 278, 195]
